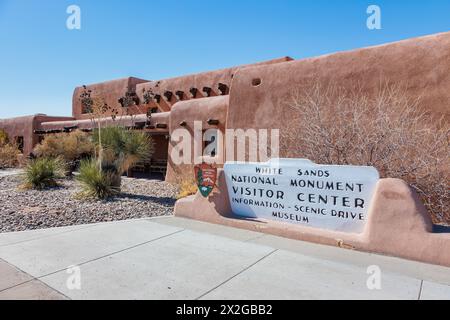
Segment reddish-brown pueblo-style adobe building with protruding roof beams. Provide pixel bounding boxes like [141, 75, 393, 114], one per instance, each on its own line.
[0, 32, 450, 181]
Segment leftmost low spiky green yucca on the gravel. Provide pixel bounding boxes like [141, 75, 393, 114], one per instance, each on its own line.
[22, 158, 66, 190]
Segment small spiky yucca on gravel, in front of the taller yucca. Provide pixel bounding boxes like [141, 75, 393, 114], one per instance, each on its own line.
[75, 159, 120, 199]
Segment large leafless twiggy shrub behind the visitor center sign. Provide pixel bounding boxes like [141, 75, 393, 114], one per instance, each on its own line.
[281, 83, 450, 224]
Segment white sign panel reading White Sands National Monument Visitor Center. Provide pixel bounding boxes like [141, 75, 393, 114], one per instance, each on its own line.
[224, 159, 379, 233]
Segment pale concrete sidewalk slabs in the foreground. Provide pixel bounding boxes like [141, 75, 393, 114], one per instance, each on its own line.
[0, 217, 450, 299]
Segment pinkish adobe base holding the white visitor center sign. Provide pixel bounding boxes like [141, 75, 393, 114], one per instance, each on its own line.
[175, 170, 450, 267]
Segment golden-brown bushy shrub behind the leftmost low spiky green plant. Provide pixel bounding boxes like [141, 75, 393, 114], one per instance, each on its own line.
[34, 130, 94, 169]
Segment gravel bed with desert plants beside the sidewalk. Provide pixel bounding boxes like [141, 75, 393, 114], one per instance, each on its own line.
[0, 175, 176, 232]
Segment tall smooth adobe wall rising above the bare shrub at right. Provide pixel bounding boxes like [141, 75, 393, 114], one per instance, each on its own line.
[227, 32, 450, 142]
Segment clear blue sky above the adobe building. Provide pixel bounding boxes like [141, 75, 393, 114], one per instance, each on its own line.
[0, 0, 450, 118]
